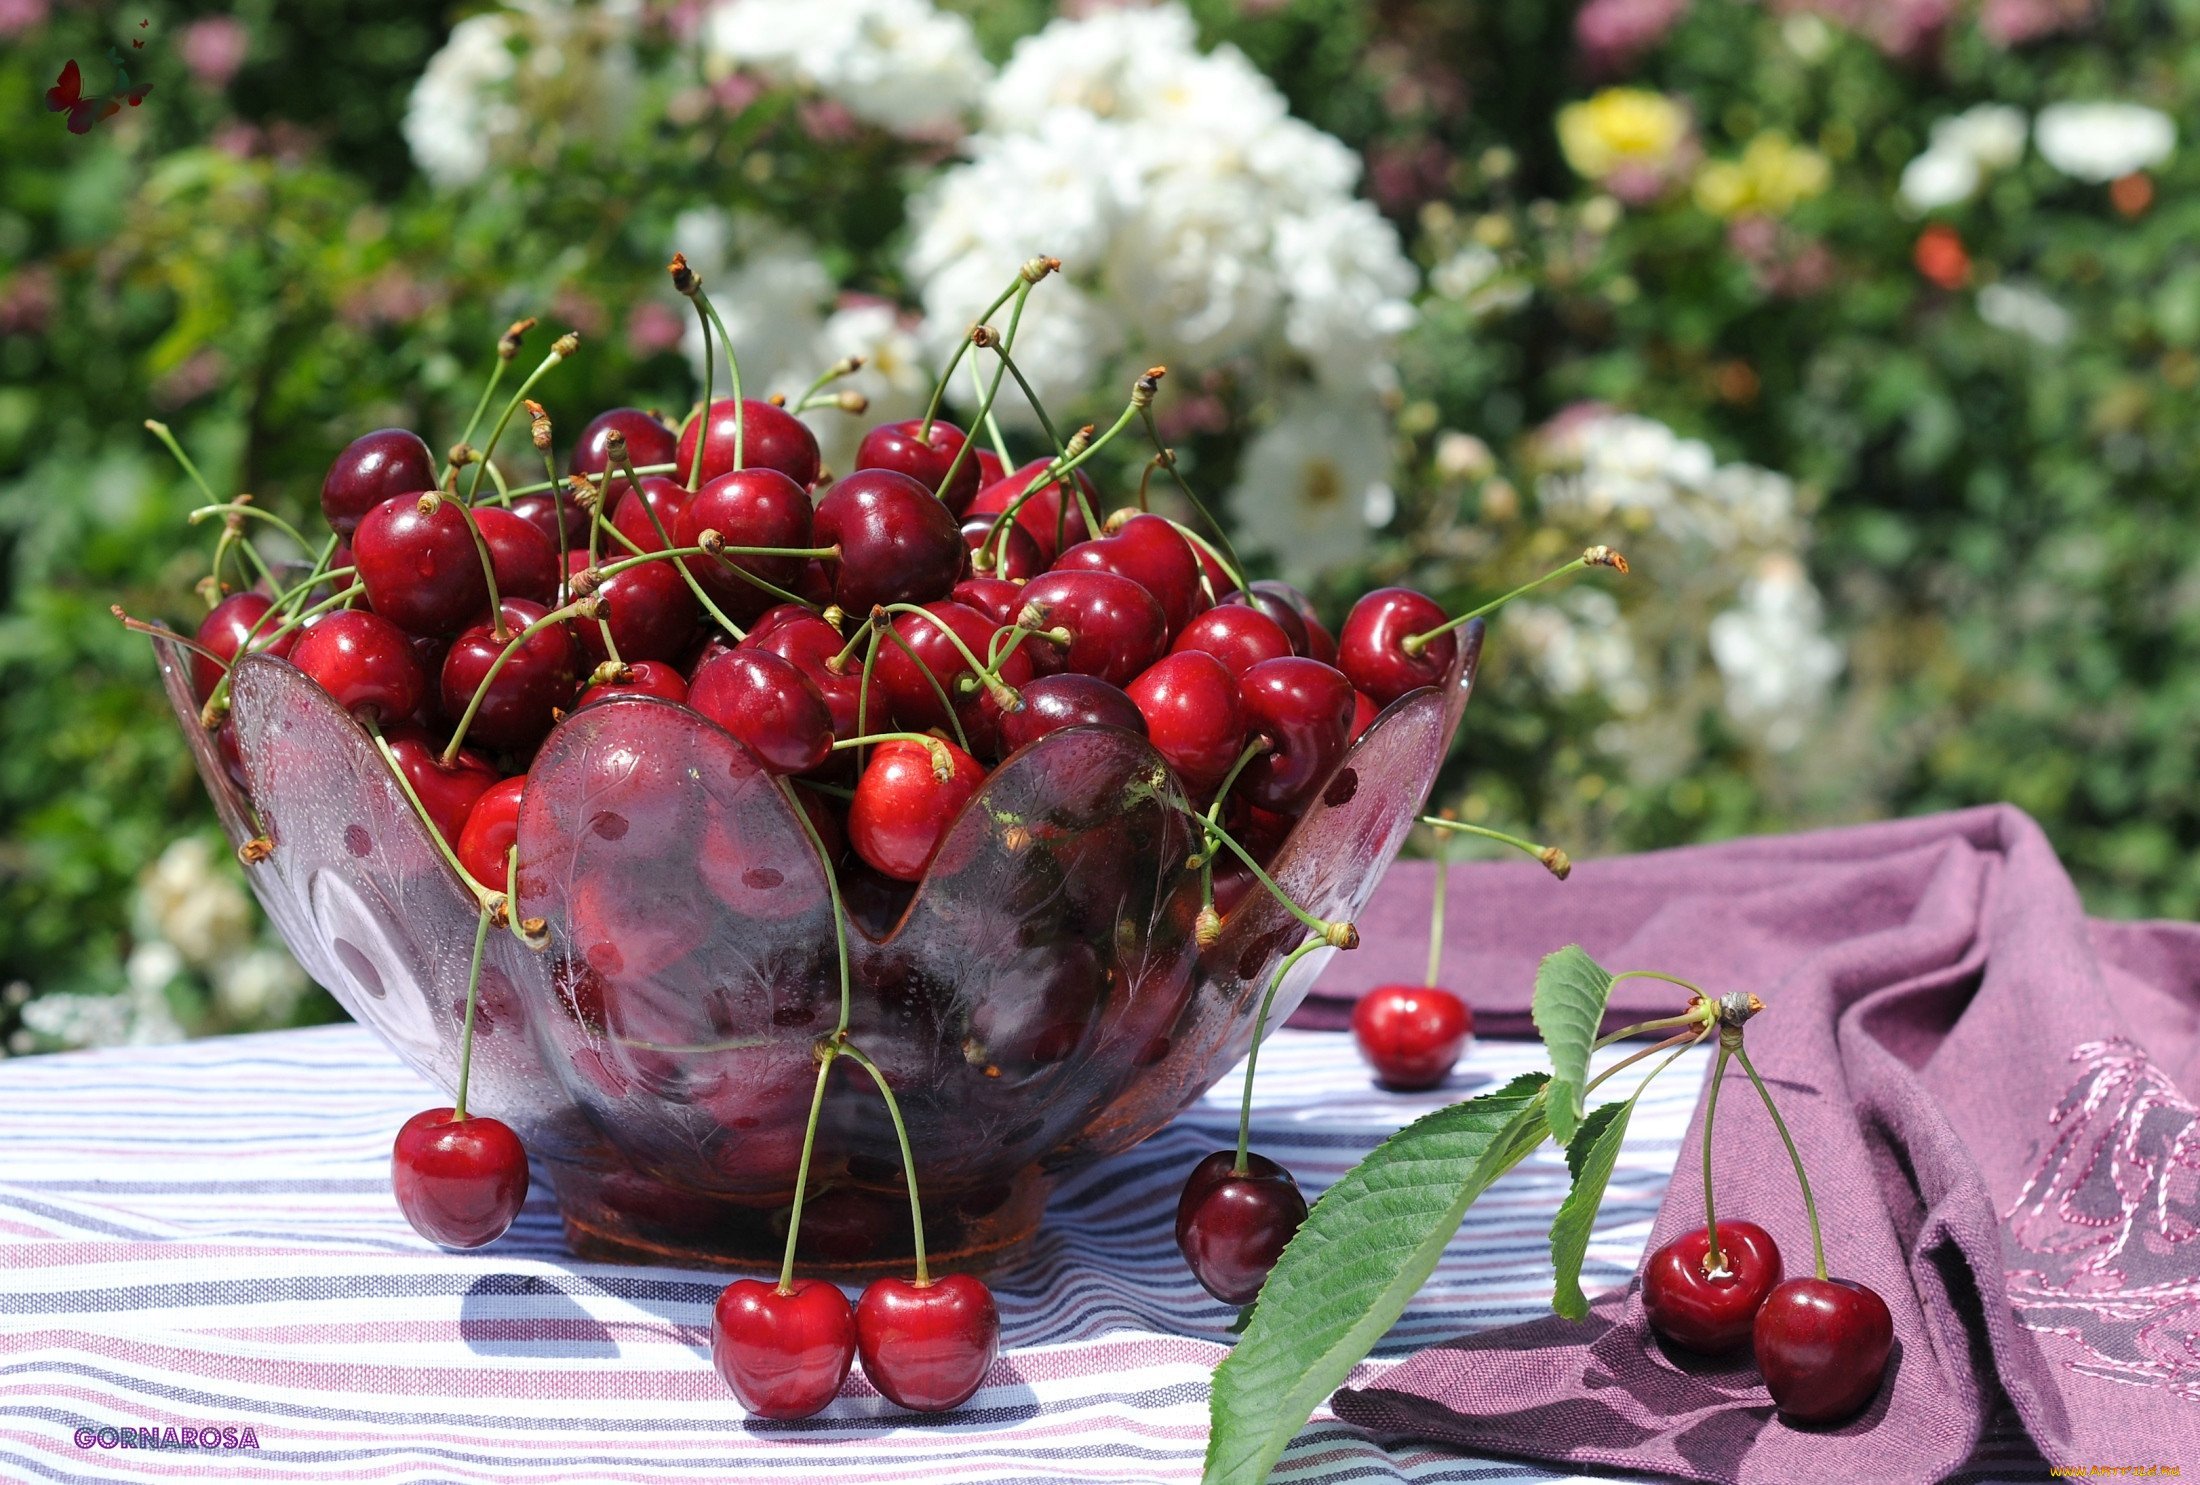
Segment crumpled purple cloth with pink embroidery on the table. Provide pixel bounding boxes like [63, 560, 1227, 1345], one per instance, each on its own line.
[1322, 807, 2200, 1485]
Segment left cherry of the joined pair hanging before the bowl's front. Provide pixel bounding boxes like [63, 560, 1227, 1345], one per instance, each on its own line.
[711, 1278, 856, 1419]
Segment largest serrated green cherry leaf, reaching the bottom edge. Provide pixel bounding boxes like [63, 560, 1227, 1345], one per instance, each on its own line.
[1201, 1074, 1549, 1485]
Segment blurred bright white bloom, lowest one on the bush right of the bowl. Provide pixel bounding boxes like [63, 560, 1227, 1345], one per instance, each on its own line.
[1709, 557, 1841, 750]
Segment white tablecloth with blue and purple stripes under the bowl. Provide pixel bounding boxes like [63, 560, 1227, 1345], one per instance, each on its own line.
[0, 1027, 2044, 1485]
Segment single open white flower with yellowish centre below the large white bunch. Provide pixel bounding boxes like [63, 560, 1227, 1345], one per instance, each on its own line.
[1230, 387, 1397, 581]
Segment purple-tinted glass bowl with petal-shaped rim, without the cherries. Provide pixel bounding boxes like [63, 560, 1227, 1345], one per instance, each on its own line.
[158, 623, 1483, 1278]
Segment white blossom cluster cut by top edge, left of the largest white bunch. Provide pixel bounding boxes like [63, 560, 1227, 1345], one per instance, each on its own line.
[702, 0, 988, 134]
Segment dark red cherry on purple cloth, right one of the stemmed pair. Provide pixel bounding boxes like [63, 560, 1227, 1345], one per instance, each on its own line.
[1751, 1276, 1894, 1423]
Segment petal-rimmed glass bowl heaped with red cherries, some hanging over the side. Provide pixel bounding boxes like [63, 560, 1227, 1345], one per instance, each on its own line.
[132, 260, 1617, 1410]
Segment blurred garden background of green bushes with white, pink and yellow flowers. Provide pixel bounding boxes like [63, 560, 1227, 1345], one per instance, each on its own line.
[0, 0, 2200, 1052]
